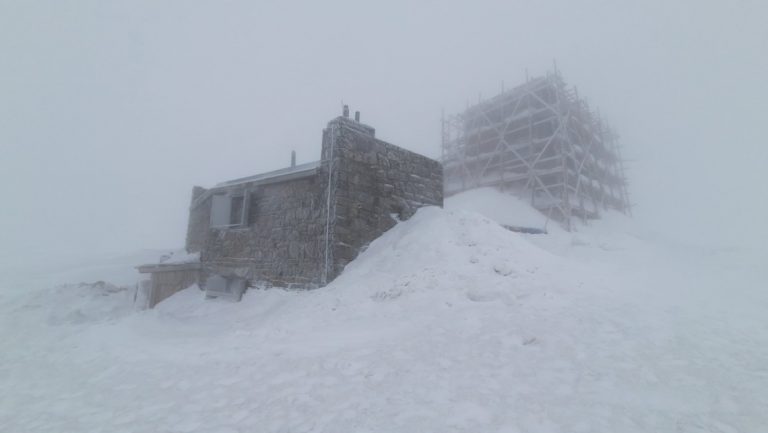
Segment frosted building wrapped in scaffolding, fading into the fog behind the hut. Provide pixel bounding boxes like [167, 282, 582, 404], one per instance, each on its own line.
[443, 71, 630, 230]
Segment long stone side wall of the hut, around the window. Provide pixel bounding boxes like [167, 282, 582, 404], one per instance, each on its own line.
[188, 174, 325, 287]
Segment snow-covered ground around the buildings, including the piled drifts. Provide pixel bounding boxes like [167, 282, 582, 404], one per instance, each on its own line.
[0, 191, 768, 433]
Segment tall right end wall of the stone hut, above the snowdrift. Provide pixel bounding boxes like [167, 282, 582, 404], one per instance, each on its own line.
[323, 117, 443, 280]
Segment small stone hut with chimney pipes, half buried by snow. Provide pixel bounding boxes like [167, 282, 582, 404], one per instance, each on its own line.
[139, 106, 443, 307]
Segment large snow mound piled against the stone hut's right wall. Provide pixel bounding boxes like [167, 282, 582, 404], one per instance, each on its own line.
[330, 207, 557, 300]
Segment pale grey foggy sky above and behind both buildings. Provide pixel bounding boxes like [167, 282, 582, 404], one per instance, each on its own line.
[0, 0, 768, 261]
